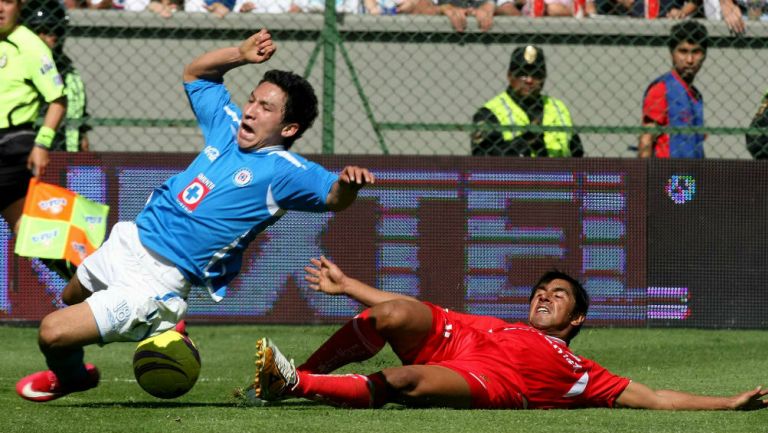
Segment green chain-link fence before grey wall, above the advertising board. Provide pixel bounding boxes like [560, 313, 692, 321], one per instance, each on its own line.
[40, 10, 768, 158]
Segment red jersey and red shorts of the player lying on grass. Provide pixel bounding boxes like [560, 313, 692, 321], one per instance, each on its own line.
[399, 302, 629, 409]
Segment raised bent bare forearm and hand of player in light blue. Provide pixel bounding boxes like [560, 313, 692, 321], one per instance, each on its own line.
[184, 29, 277, 82]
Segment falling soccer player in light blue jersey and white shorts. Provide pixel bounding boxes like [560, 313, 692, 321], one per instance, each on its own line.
[16, 29, 374, 402]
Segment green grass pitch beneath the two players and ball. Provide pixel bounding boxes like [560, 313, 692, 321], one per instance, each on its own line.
[0, 323, 768, 433]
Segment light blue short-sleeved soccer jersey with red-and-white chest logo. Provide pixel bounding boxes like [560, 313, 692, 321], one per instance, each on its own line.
[136, 80, 338, 301]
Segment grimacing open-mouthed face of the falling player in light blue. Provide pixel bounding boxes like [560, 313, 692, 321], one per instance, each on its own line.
[237, 81, 286, 149]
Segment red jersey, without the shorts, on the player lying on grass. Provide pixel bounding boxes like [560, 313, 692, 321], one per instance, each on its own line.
[492, 323, 630, 409]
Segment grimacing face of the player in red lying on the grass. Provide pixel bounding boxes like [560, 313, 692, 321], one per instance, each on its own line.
[528, 278, 576, 335]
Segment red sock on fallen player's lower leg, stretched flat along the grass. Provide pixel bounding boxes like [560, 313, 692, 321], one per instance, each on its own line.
[290, 371, 387, 409]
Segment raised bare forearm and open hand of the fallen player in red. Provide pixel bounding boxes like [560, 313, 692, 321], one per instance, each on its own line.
[304, 256, 418, 307]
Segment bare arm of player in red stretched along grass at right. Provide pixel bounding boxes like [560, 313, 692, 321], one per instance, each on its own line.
[616, 382, 768, 410]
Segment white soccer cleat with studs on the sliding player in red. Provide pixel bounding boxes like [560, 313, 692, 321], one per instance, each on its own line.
[253, 337, 299, 401]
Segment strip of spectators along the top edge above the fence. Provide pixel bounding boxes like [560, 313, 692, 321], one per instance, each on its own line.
[55, 0, 768, 33]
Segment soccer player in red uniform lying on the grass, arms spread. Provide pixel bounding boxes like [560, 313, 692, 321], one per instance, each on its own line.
[246, 257, 768, 410]
